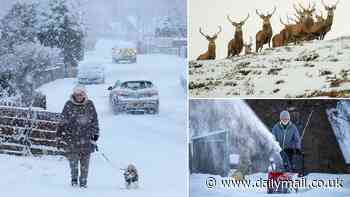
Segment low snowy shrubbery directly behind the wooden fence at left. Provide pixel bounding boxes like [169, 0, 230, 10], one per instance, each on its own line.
[0, 80, 46, 109]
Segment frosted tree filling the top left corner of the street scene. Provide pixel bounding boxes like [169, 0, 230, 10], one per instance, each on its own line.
[0, 2, 38, 50]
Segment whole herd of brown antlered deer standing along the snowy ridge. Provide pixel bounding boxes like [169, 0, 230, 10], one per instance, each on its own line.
[197, 0, 339, 60]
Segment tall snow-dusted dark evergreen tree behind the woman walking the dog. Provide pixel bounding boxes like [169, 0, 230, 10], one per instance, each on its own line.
[39, 0, 84, 66]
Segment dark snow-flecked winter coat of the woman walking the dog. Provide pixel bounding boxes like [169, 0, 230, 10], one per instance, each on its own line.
[57, 96, 99, 154]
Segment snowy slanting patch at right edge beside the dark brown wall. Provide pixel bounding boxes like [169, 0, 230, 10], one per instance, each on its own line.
[327, 100, 350, 165]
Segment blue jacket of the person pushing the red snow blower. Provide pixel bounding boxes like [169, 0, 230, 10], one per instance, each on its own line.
[272, 122, 301, 150]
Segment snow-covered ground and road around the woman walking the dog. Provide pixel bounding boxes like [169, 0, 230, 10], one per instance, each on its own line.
[0, 40, 188, 197]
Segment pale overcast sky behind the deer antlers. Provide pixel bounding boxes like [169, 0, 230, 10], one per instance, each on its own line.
[188, 0, 350, 60]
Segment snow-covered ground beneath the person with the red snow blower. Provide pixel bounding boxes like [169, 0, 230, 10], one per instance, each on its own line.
[190, 173, 350, 197]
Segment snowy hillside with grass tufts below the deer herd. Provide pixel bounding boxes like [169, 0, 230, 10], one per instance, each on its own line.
[189, 37, 350, 97]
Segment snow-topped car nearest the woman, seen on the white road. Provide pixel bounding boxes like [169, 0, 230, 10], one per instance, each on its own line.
[108, 80, 159, 114]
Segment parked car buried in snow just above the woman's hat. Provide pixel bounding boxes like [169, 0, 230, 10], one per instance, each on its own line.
[78, 65, 105, 84]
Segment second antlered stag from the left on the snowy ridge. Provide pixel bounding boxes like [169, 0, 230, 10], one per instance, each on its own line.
[227, 14, 249, 58]
